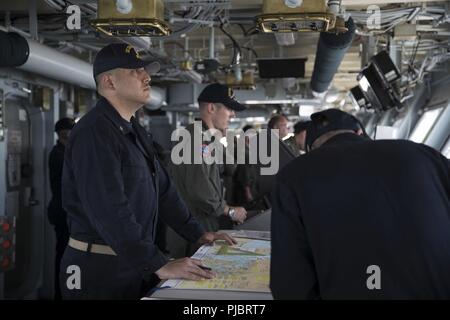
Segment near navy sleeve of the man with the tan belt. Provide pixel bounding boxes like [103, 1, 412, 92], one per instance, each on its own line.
[70, 123, 167, 275]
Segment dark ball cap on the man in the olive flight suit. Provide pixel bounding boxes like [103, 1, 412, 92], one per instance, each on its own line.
[197, 83, 245, 111]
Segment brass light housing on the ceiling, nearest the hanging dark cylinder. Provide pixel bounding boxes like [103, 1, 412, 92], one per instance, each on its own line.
[256, 0, 336, 33]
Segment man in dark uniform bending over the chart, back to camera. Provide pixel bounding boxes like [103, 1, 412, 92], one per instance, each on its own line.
[270, 109, 450, 299]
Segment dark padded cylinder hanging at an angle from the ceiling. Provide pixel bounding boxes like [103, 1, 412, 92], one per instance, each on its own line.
[311, 18, 356, 94]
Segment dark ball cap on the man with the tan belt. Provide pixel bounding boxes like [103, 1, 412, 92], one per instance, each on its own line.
[94, 43, 160, 78]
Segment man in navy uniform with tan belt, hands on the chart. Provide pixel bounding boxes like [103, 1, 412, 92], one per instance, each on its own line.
[60, 44, 234, 299]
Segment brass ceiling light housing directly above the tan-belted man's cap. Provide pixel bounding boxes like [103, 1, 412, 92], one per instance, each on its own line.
[90, 0, 172, 37]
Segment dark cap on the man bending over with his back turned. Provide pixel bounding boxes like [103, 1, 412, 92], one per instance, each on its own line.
[306, 109, 360, 148]
